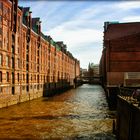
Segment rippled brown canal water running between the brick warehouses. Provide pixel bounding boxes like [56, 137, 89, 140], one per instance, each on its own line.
[0, 84, 115, 140]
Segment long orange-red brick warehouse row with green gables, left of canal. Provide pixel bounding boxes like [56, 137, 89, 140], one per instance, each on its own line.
[0, 0, 80, 107]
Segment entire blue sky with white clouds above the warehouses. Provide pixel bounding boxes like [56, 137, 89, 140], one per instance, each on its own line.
[19, 0, 140, 68]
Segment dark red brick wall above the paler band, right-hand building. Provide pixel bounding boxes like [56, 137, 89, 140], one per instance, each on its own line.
[101, 23, 140, 85]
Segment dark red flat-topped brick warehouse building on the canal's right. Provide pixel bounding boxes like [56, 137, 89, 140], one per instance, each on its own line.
[100, 22, 140, 106]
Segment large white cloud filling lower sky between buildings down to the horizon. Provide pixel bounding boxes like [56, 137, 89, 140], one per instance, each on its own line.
[47, 19, 103, 68]
